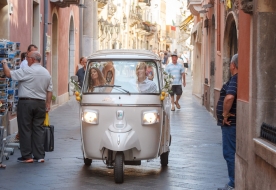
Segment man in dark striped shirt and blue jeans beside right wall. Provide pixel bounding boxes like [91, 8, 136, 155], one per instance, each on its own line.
[216, 54, 238, 190]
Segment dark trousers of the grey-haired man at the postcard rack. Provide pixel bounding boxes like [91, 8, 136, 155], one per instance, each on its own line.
[17, 100, 46, 159]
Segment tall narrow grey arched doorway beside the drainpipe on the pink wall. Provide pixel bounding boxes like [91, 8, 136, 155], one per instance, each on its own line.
[51, 13, 58, 104]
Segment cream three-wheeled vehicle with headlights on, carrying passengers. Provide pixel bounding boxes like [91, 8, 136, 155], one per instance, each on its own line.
[80, 50, 171, 183]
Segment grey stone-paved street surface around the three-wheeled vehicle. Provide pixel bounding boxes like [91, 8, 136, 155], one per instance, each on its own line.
[0, 72, 227, 190]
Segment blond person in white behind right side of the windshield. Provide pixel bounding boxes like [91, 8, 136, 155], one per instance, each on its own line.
[136, 62, 157, 93]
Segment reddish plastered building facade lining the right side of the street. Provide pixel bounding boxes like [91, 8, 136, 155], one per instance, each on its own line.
[188, 0, 276, 190]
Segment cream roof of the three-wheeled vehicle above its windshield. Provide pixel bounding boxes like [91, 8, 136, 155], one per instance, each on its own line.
[87, 49, 160, 60]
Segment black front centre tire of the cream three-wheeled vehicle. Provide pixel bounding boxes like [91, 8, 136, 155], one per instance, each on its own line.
[114, 152, 125, 183]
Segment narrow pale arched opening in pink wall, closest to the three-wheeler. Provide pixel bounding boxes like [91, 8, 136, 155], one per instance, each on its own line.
[68, 16, 75, 95]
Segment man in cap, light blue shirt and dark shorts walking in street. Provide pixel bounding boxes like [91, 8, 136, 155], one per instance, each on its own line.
[165, 54, 186, 111]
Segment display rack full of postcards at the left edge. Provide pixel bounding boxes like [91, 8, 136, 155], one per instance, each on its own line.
[0, 40, 21, 168]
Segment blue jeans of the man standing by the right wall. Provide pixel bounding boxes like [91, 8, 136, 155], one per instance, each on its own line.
[221, 126, 236, 187]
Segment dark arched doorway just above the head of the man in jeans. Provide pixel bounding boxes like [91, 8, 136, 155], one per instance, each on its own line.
[223, 12, 238, 82]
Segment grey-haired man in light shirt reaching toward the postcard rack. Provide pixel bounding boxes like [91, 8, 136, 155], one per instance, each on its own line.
[2, 51, 53, 163]
